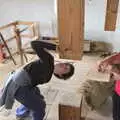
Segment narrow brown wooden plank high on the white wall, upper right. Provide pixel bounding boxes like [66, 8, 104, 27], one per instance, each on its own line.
[104, 0, 119, 31]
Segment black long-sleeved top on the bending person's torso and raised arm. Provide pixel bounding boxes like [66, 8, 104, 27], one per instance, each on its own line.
[24, 41, 56, 86]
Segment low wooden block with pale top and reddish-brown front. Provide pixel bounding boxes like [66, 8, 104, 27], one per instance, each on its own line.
[59, 93, 84, 120]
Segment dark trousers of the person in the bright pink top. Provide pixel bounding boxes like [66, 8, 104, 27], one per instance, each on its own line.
[112, 92, 120, 120]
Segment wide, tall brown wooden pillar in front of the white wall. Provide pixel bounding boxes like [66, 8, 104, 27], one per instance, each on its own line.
[58, 0, 85, 60]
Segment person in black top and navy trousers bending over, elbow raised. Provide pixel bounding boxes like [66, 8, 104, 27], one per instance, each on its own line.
[0, 41, 74, 120]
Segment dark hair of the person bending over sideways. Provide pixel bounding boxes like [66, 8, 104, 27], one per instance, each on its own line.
[54, 63, 75, 80]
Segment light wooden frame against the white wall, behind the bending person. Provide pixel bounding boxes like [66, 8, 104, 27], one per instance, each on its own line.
[0, 21, 40, 65]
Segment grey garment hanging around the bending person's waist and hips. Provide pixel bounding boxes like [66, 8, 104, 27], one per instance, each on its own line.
[0, 69, 31, 109]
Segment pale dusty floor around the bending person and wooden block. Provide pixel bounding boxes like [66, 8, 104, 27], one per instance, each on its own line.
[0, 54, 112, 120]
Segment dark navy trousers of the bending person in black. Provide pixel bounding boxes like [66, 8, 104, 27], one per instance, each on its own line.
[15, 86, 46, 120]
